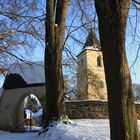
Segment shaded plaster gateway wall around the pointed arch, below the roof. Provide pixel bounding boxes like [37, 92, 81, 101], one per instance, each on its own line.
[0, 86, 45, 132]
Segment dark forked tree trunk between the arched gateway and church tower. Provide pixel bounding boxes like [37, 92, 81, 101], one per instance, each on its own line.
[44, 0, 69, 127]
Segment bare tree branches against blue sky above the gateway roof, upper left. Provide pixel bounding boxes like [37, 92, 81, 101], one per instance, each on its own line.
[0, 0, 45, 72]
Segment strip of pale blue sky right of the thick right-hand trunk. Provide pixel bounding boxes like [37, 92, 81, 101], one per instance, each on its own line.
[126, 6, 140, 84]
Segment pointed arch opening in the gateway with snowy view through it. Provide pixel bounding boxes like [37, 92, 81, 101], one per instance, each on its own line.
[23, 93, 44, 131]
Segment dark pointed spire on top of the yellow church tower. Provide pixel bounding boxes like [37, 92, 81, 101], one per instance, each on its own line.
[83, 29, 100, 49]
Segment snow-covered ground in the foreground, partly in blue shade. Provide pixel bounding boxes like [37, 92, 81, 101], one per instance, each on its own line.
[0, 119, 140, 140]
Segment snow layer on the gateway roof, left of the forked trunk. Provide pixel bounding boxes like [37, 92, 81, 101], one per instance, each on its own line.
[8, 61, 45, 84]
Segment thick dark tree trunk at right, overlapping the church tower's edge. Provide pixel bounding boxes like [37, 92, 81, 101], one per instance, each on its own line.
[95, 0, 139, 140]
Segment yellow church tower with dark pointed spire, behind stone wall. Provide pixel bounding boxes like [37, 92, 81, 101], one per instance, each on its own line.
[77, 30, 107, 100]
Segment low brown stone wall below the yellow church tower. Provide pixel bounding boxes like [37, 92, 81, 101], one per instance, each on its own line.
[66, 101, 140, 119]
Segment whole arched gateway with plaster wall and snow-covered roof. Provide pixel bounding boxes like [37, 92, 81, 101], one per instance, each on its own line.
[0, 64, 45, 132]
